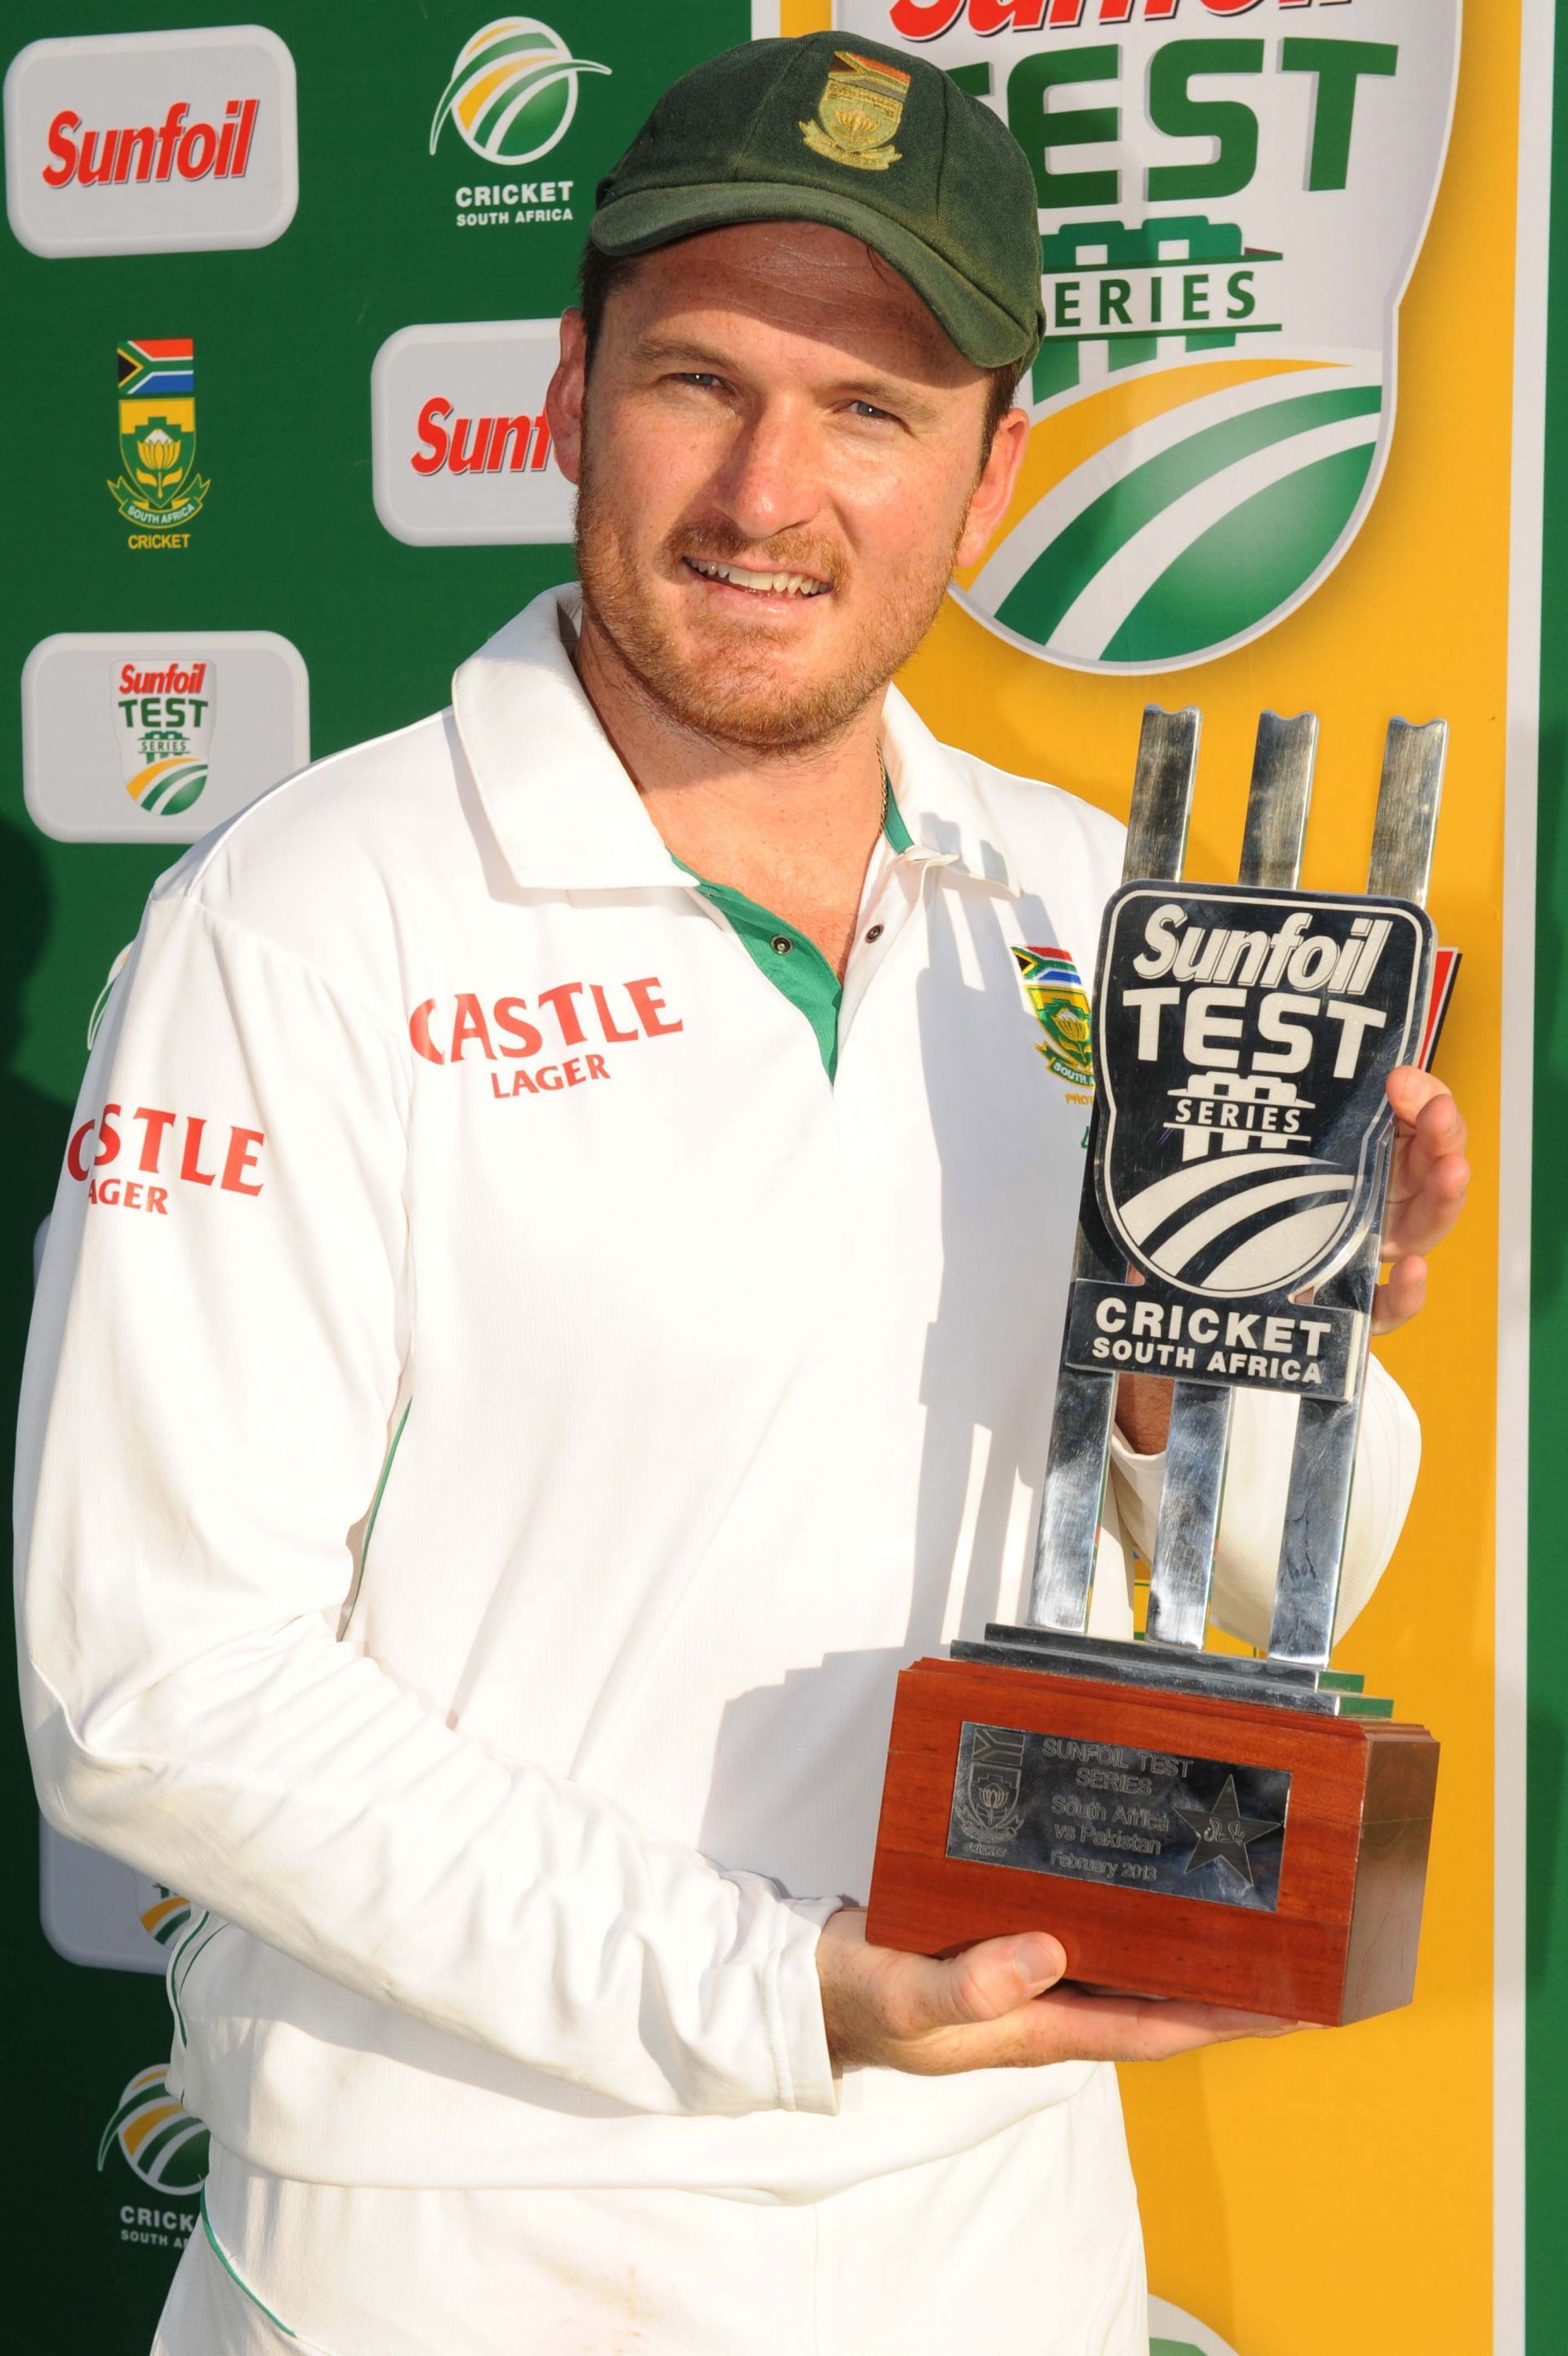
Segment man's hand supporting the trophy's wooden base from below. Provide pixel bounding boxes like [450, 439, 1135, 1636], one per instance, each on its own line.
[817, 1906, 1299, 2078]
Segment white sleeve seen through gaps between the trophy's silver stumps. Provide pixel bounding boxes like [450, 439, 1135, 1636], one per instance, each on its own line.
[1111, 1357, 1422, 1645]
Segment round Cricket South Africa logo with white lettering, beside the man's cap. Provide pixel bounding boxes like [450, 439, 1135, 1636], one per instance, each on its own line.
[431, 16, 610, 229]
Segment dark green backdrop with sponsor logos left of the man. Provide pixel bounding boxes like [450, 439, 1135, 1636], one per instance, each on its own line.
[0, 13, 751, 2356]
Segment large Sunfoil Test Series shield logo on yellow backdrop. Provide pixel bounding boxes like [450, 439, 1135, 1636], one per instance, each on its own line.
[834, 0, 1462, 671]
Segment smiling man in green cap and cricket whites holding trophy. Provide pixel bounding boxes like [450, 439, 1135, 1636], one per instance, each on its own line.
[21, 38, 1464, 2356]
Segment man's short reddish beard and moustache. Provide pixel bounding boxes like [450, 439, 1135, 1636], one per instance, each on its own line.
[577, 421, 963, 751]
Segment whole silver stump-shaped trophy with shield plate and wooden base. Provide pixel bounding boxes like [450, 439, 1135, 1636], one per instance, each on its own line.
[866, 709, 1448, 2024]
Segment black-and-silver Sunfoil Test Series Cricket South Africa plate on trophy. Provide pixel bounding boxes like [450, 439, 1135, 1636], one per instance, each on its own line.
[1067, 884, 1434, 1400]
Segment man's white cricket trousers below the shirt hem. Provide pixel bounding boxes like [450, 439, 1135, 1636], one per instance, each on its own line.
[153, 2071, 1149, 2356]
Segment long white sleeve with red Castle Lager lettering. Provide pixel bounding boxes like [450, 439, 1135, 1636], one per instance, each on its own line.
[16, 891, 835, 2113]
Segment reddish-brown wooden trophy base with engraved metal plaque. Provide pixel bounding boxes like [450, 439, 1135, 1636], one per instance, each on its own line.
[866, 1647, 1438, 2026]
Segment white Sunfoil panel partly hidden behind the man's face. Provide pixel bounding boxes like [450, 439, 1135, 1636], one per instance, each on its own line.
[370, 318, 574, 546]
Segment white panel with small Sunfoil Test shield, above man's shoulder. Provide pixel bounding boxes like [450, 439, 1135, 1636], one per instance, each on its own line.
[21, 629, 311, 844]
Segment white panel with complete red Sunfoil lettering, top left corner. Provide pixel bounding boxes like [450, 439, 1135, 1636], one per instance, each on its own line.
[5, 24, 299, 256]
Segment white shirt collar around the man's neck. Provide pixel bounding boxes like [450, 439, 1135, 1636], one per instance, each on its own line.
[452, 589, 1017, 893]
